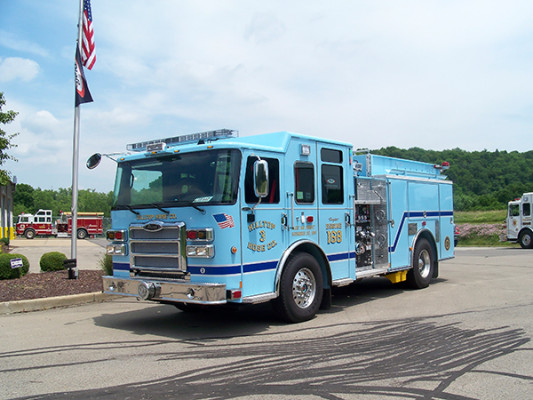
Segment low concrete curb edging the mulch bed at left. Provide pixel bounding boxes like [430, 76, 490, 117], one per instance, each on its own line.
[0, 292, 113, 315]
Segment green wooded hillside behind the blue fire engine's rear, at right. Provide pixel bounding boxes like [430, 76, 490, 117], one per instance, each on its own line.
[372, 147, 533, 211]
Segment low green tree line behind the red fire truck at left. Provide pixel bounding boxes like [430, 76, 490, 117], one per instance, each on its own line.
[13, 183, 113, 217]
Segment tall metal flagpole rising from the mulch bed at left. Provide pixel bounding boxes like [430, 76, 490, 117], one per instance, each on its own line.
[69, 0, 83, 279]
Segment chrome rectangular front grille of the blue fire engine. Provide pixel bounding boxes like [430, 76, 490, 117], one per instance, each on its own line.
[129, 222, 187, 277]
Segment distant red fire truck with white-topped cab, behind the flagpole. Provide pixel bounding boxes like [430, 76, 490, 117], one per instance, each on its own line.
[17, 210, 104, 239]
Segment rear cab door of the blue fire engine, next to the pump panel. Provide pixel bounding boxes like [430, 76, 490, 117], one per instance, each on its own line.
[317, 143, 355, 281]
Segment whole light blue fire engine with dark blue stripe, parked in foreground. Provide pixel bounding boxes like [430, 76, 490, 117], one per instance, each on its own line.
[87, 129, 454, 322]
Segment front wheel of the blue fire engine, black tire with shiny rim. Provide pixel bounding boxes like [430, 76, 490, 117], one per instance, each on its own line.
[273, 253, 324, 322]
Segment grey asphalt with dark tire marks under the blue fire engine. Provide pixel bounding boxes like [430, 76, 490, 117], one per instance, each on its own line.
[0, 248, 533, 400]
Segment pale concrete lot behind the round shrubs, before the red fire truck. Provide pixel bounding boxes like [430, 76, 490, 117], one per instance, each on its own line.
[9, 237, 107, 273]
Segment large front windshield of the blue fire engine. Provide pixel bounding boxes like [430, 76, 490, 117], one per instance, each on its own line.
[113, 150, 241, 208]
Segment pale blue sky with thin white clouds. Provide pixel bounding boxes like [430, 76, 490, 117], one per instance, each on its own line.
[0, 0, 533, 192]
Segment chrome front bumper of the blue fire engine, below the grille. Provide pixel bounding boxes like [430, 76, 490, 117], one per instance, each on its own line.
[102, 276, 226, 304]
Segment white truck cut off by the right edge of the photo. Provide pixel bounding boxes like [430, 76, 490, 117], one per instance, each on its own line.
[502, 193, 533, 249]
